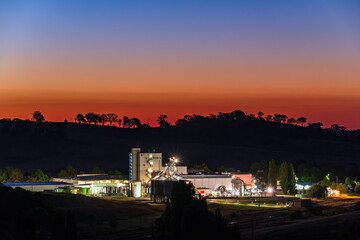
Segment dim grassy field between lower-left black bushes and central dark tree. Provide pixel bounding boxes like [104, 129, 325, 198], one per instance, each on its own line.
[43, 193, 165, 240]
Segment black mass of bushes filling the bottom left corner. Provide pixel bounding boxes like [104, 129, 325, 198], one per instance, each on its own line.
[0, 186, 77, 240]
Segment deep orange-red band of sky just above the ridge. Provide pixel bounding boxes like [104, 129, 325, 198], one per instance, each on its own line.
[0, 91, 360, 129]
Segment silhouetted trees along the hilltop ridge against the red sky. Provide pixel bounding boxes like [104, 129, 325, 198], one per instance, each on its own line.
[0, 110, 352, 131]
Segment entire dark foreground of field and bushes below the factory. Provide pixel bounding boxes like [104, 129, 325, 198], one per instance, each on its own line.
[0, 184, 360, 240]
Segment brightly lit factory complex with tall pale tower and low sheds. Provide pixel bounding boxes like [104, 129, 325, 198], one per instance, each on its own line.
[4, 148, 255, 200]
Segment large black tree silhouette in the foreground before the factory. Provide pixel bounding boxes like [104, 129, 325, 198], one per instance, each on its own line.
[155, 182, 240, 239]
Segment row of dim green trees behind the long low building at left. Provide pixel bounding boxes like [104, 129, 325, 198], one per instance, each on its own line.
[0, 165, 123, 182]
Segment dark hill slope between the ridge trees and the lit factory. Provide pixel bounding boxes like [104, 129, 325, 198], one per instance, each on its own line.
[0, 119, 360, 175]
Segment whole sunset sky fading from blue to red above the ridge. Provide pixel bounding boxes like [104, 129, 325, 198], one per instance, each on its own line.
[0, 0, 360, 129]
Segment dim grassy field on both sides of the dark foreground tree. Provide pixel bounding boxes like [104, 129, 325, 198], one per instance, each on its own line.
[43, 193, 360, 240]
